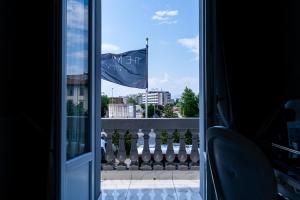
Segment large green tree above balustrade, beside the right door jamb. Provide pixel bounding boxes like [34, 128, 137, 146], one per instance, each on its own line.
[180, 87, 199, 117]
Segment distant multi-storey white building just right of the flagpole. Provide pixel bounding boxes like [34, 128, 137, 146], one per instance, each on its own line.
[142, 91, 171, 106]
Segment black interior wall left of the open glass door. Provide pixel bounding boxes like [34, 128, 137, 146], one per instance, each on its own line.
[0, 0, 56, 199]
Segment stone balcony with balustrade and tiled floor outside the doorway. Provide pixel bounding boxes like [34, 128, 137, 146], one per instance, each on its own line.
[101, 118, 200, 200]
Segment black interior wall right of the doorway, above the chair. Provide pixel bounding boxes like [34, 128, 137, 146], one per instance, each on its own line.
[212, 0, 300, 153]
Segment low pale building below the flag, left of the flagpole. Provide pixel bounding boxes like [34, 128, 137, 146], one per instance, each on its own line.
[108, 104, 136, 118]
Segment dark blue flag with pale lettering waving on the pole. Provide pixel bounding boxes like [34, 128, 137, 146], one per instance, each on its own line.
[101, 48, 148, 89]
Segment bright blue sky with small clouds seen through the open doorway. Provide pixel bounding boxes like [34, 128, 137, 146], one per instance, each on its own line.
[102, 0, 199, 98]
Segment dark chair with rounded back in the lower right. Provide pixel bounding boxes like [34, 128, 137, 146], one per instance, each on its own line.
[207, 127, 277, 200]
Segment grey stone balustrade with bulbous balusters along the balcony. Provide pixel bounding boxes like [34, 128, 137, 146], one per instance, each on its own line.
[102, 118, 199, 170]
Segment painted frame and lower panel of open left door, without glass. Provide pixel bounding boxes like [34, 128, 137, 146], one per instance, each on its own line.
[59, 0, 101, 200]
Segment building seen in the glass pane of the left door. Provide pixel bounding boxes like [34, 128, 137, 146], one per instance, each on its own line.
[67, 74, 88, 111]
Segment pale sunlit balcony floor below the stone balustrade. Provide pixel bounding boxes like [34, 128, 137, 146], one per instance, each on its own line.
[101, 171, 200, 200]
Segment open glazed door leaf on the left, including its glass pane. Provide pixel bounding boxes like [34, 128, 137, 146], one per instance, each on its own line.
[60, 0, 101, 200]
